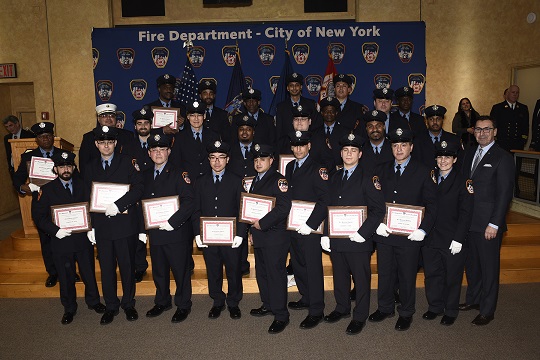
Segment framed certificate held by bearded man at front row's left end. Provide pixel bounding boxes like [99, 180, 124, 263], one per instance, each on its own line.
[51, 202, 92, 233]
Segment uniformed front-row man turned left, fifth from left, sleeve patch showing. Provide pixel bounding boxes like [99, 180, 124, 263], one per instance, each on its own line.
[249, 144, 291, 334]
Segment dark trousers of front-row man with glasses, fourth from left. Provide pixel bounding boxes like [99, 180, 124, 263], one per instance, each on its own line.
[203, 246, 243, 308]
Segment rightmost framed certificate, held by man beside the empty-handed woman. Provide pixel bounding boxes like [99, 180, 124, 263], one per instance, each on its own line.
[384, 203, 424, 235]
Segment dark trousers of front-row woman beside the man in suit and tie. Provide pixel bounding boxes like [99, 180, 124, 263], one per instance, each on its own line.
[422, 246, 467, 317]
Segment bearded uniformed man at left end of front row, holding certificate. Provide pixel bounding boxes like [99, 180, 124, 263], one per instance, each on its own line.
[32, 151, 105, 325]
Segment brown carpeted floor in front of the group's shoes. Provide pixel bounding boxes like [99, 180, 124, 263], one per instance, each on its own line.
[0, 284, 540, 360]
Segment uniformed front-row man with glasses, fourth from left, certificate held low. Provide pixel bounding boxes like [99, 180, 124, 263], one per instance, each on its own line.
[192, 141, 247, 320]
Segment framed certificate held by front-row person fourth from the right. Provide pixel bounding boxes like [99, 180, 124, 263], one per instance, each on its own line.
[328, 206, 367, 238]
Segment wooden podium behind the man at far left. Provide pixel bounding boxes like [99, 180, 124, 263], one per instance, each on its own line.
[9, 137, 73, 237]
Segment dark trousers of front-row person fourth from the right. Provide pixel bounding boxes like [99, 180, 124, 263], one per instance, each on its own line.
[330, 250, 371, 322]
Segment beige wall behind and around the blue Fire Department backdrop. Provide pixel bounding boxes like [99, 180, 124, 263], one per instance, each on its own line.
[0, 0, 540, 216]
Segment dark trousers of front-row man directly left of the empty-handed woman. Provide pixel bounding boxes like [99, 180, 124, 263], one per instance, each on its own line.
[377, 243, 420, 317]
